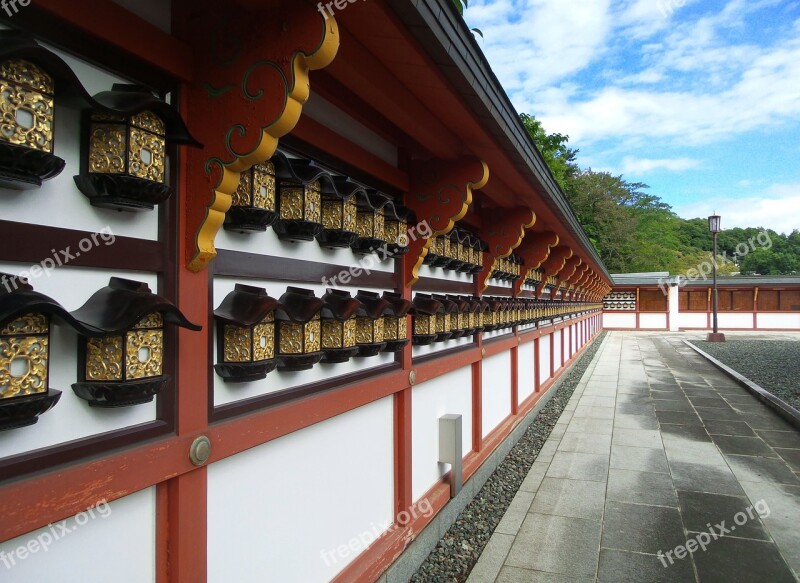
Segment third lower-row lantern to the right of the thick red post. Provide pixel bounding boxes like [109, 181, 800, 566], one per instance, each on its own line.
[321, 289, 361, 364]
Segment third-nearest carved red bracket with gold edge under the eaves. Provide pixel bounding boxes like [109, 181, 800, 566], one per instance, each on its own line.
[477, 207, 536, 294]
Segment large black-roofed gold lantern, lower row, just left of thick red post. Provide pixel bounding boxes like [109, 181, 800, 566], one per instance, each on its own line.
[72, 277, 202, 408]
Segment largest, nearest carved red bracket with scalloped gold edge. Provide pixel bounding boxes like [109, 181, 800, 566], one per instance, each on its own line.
[182, 0, 339, 272]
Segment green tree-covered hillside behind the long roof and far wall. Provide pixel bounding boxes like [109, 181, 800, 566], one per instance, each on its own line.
[521, 114, 800, 275]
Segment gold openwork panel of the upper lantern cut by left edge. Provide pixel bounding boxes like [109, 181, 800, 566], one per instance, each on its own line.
[0, 59, 55, 154]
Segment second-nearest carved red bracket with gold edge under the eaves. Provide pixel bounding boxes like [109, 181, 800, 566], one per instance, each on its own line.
[403, 157, 489, 287]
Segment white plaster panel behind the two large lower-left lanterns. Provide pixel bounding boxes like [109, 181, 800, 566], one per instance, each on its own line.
[0, 262, 158, 458]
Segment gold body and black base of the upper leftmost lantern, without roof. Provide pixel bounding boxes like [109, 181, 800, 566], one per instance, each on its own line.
[0, 59, 65, 190]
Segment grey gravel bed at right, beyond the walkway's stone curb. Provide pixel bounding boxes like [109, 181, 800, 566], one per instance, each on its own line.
[692, 337, 800, 409]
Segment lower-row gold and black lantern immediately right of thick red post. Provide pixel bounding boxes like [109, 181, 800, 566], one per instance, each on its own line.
[214, 284, 280, 383]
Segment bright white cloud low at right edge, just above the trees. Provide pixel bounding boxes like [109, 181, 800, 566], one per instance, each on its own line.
[673, 184, 800, 234]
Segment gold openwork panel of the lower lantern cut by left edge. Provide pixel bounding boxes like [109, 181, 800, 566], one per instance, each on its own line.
[0, 314, 50, 400]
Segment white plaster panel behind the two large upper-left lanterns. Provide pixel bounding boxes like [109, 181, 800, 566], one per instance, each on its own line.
[0, 39, 158, 240]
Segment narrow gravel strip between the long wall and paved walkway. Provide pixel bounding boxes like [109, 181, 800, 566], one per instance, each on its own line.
[411, 332, 606, 583]
